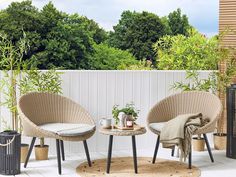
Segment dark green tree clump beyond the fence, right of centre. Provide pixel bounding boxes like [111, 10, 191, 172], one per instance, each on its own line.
[109, 9, 190, 60]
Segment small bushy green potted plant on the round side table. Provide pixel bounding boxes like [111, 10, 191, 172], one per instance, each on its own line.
[112, 103, 139, 128]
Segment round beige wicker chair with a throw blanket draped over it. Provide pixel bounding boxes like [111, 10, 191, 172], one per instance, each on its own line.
[147, 91, 222, 168]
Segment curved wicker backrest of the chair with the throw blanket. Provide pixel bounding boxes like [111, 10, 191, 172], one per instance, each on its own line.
[147, 91, 222, 123]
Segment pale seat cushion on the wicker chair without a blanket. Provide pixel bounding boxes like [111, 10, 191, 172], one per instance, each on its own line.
[39, 123, 95, 136]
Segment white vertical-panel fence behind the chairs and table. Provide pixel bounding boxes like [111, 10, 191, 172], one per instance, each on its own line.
[0, 70, 210, 153]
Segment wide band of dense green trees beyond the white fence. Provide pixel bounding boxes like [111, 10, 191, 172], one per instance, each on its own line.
[0, 0, 195, 69]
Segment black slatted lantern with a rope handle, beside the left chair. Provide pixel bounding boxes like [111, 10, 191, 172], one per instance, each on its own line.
[0, 131, 21, 175]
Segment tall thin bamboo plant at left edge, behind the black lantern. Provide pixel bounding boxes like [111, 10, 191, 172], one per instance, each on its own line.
[0, 34, 27, 130]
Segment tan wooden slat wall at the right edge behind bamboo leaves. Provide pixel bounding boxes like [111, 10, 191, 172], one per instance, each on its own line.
[219, 0, 236, 132]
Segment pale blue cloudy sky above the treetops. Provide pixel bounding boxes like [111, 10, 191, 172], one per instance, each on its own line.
[0, 0, 219, 37]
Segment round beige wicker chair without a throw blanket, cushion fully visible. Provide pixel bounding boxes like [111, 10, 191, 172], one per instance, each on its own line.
[18, 92, 95, 174]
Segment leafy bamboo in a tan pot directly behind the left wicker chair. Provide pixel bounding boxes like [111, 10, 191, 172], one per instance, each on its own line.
[20, 69, 62, 160]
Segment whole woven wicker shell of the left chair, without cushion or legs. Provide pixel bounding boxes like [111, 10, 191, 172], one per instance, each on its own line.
[17, 92, 95, 141]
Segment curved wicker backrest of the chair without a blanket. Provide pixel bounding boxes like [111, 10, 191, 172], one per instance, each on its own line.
[18, 92, 94, 125]
